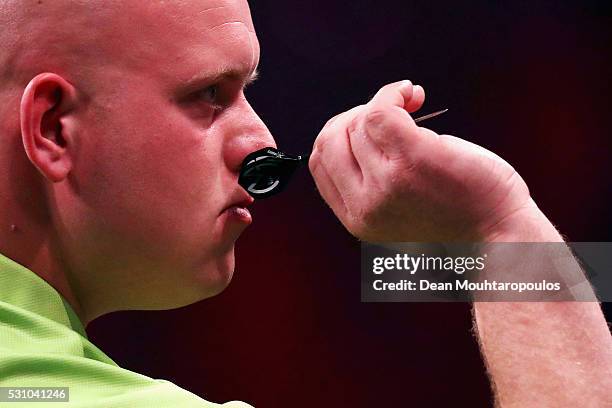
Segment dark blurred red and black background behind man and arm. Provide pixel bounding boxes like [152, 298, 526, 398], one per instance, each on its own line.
[88, 0, 612, 407]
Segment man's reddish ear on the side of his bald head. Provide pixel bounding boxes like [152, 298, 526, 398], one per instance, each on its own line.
[20, 73, 76, 183]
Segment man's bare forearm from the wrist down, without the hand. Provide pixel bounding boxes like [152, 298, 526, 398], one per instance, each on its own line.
[474, 209, 612, 408]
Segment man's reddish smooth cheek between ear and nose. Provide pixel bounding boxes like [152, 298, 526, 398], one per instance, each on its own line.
[74, 99, 224, 245]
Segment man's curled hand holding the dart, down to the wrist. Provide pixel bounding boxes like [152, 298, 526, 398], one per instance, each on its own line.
[309, 81, 535, 242]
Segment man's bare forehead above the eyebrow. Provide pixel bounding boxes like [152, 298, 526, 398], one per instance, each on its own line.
[105, 0, 259, 86]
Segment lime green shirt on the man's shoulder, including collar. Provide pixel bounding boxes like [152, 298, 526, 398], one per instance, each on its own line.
[0, 254, 250, 408]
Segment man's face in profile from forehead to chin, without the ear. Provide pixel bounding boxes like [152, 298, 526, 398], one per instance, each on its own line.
[53, 0, 274, 316]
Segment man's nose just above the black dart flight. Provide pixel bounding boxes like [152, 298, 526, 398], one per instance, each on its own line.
[223, 98, 276, 174]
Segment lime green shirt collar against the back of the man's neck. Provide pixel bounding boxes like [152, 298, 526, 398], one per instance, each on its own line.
[0, 254, 87, 338]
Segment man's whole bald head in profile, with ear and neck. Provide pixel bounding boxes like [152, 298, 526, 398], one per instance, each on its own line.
[0, 0, 274, 321]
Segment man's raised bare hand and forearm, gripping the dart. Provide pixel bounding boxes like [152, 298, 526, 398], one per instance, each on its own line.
[310, 82, 612, 407]
